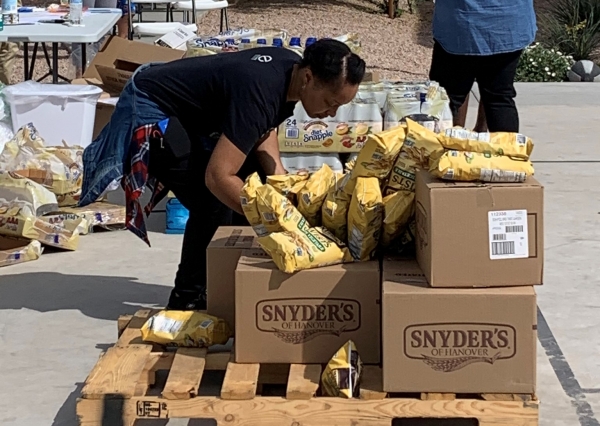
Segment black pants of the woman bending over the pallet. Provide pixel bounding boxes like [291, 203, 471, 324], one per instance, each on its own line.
[148, 131, 258, 301]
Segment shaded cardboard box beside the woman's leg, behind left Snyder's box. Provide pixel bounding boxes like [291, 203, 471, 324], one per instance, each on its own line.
[206, 226, 258, 329]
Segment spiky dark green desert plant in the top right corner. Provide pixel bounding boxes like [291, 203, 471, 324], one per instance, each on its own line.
[540, 0, 600, 60]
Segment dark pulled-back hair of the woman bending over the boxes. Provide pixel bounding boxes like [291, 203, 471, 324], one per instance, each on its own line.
[300, 39, 366, 86]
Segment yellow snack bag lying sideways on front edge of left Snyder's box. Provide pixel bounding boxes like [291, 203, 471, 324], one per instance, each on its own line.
[258, 223, 352, 274]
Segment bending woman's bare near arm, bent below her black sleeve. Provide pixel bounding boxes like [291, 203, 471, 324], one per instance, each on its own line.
[205, 134, 246, 215]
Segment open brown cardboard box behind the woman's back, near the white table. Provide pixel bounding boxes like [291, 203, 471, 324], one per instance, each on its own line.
[73, 36, 185, 97]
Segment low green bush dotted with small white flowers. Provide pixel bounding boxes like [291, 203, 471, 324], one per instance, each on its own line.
[515, 43, 573, 82]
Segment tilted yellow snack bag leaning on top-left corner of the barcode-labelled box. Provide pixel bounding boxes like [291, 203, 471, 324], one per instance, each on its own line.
[383, 118, 444, 195]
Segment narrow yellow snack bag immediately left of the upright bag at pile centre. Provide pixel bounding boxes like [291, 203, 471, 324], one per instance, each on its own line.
[321, 174, 352, 241]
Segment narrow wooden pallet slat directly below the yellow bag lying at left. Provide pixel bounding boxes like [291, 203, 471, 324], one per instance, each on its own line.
[162, 348, 206, 399]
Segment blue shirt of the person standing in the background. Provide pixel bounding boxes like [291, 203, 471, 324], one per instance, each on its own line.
[433, 0, 537, 56]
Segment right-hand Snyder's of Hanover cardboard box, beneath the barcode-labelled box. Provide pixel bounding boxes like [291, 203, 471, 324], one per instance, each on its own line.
[382, 260, 537, 394]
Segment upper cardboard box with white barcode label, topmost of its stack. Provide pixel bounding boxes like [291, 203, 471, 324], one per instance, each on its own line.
[415, 172, 544, 287]
